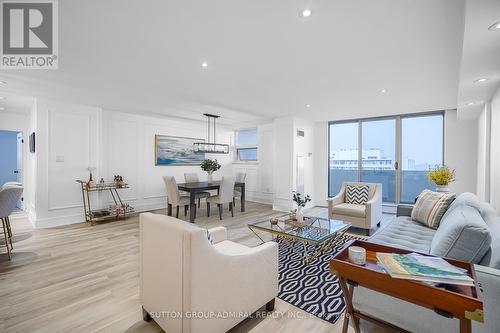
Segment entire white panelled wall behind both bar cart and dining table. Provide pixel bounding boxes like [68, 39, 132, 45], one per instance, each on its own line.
[30, 100, 233, 227]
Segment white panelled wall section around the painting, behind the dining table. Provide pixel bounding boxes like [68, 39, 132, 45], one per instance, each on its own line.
[102, 111, 233, 211]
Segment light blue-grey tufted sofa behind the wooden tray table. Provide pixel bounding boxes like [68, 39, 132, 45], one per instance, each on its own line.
[353, 193, 500, 333]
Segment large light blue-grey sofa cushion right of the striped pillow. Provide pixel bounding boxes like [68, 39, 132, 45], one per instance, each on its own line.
[430, 205, 491, 263]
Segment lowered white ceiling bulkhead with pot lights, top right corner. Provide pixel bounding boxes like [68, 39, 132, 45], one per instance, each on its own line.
[458, 0, 500, 118]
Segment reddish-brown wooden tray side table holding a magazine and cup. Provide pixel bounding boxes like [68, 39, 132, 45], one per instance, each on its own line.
[330, 240, 484, 333]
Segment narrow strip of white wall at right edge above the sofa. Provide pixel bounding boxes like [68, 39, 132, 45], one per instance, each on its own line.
[490, 85, 500, 213]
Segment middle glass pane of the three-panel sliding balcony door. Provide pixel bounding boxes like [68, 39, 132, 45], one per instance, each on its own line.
[361, 118, 396, 203]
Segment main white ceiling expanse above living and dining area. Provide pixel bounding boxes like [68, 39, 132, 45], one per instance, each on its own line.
[0, 0, 465, 127]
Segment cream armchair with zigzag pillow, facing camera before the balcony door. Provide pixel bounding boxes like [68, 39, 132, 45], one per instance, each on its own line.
[328, 182, 382, 234]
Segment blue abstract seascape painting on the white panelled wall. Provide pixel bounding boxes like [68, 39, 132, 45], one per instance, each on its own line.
[155, 135, 205, 165]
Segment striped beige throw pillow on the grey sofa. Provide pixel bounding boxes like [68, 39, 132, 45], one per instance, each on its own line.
[411, 190, 455, 229]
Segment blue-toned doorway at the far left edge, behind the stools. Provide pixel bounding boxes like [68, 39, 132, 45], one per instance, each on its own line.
[0, 130, 23, 209]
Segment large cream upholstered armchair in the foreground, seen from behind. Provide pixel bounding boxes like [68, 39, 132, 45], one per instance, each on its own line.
[140, 213, 278, 333]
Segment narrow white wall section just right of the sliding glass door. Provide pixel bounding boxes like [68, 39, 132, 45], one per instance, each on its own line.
[444, 110, 478, 193]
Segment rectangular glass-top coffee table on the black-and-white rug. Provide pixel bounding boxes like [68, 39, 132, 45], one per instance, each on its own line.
[248, 214, 351, 264]
